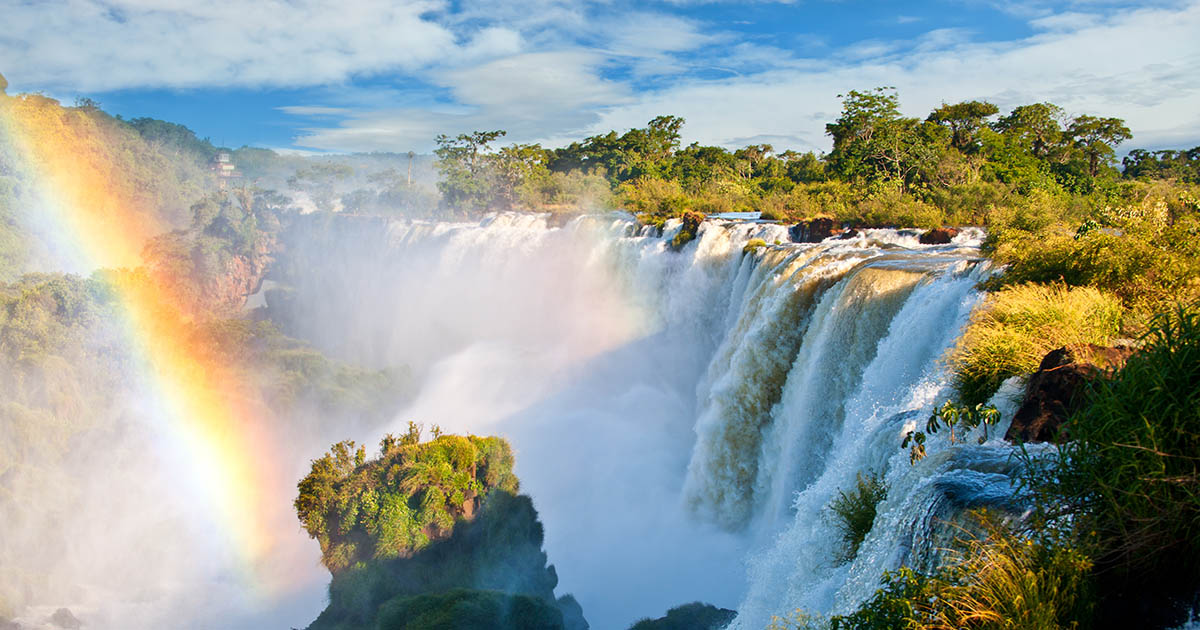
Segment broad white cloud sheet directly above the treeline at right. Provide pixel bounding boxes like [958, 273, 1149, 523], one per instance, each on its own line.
[588, 2, 1200, 150]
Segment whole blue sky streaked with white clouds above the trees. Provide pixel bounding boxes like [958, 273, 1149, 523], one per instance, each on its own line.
[0, 0, 1200, 151]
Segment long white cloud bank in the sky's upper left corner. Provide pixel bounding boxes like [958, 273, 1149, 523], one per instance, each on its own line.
[0, 0, 456, 92]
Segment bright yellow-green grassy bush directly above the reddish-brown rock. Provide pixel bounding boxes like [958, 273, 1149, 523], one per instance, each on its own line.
[949, 279, 1121, 406]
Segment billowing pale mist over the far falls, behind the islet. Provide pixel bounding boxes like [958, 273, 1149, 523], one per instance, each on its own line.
[268, 215, 772, 628]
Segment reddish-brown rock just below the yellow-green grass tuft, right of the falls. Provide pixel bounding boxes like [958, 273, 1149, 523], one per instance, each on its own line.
[1004, 343, 1134, 442]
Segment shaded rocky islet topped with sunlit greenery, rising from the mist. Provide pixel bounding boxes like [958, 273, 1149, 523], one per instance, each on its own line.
[295, 434, 587, 630]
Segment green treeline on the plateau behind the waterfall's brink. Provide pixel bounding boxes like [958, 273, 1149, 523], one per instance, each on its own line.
[436, 88, 1200, 227]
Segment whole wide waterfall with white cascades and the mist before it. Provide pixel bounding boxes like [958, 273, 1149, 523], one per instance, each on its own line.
[274, 215, 1032, 629]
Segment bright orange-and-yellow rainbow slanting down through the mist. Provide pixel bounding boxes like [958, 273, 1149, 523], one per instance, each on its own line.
[0, 92, 296, 592]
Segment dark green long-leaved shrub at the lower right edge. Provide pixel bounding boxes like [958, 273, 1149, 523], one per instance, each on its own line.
[1027, 305, 1200, 624]
